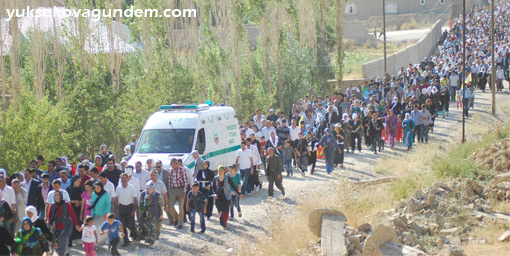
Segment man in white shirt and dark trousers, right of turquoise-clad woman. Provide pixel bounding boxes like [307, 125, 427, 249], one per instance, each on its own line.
[115, 173, 138, 246]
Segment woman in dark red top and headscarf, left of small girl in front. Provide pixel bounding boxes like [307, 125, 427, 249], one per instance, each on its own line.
[48, 190, 80, 256]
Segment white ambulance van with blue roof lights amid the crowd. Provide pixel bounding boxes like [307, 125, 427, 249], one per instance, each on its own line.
[128, 104, 241, 171]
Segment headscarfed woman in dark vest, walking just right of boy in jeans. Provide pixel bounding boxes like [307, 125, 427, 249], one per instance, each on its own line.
[213, 165, 244, 228]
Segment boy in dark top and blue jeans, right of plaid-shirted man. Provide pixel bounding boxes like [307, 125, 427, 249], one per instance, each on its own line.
[186, 181, 207, 233]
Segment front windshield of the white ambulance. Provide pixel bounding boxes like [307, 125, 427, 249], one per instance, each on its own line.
[135, 129, 195, 154]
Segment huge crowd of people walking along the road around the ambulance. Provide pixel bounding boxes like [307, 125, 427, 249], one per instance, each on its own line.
[0, 1, 510, 256]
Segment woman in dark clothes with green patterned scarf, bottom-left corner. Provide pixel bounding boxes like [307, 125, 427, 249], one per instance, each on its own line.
[11, 217, 44, 255]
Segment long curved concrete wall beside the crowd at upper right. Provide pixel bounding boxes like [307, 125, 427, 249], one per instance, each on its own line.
[362, 21, 443, 79]
